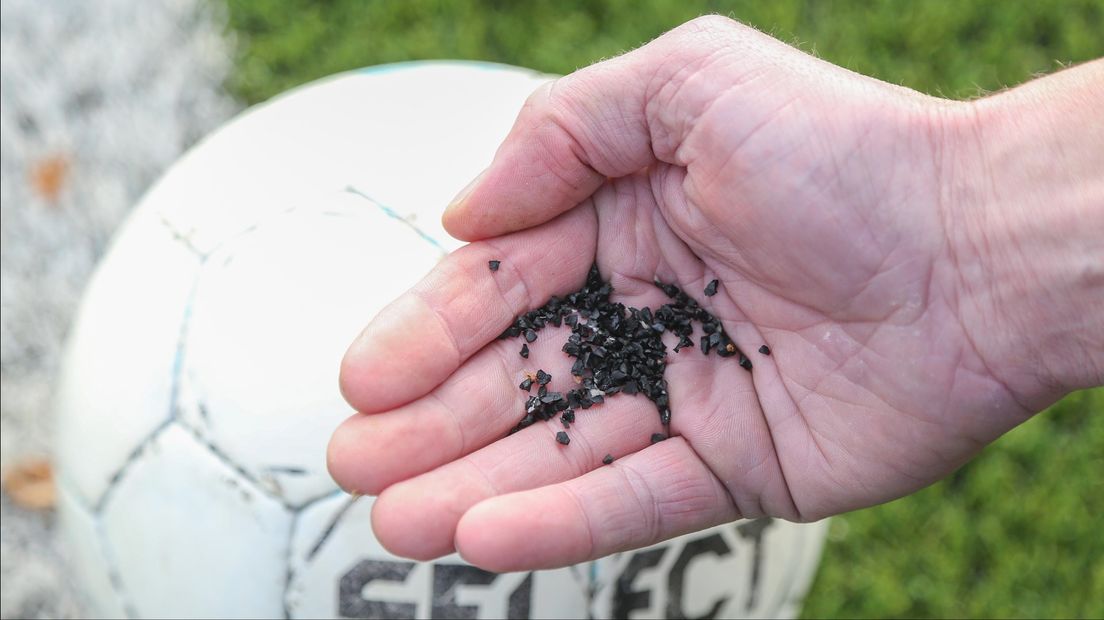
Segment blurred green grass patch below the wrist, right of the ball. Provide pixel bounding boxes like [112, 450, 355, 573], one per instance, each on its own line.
[805, 388, 1104, 618]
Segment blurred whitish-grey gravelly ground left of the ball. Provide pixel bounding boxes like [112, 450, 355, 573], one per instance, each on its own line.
[0, 0, 238, 618]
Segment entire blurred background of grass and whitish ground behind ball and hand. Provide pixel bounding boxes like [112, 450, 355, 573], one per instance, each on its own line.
[0, 0, 1104, 618]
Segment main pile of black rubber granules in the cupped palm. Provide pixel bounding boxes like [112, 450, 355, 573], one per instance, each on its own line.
[499, 266, 751, 432]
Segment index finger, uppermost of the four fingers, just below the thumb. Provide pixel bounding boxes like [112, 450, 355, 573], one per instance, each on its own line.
[340, 205, 597, 413]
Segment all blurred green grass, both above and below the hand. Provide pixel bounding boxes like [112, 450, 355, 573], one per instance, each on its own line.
[219, 0, 1104, 617]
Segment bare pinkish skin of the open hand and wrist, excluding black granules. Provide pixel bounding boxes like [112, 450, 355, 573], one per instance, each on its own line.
[328, 17, 1104, 571]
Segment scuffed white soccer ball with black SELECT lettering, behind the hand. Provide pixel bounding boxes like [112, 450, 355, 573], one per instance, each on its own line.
[57, 62, 825, 618]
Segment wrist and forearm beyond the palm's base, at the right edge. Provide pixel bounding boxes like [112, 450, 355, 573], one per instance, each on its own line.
[944, 61, 1104, 409]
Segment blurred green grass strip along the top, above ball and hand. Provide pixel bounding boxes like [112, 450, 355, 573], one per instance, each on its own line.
[230, 0, 1104, 103]
